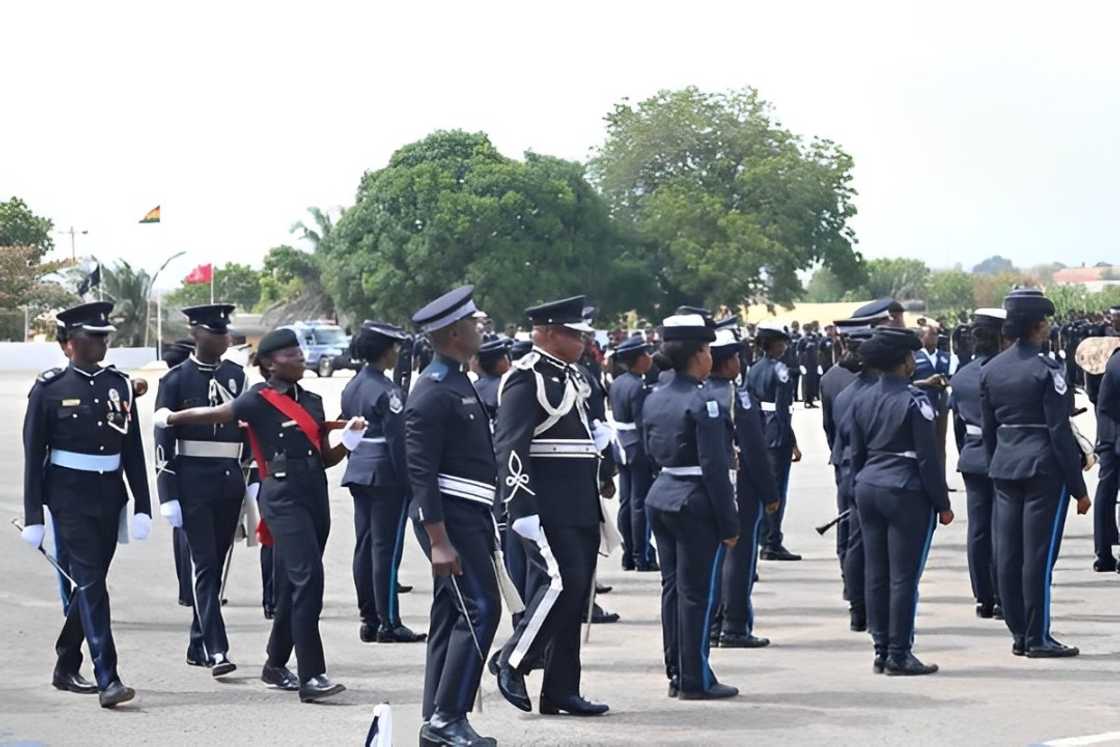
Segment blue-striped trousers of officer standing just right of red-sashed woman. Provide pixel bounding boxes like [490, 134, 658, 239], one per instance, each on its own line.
[351, 486, 409, 627]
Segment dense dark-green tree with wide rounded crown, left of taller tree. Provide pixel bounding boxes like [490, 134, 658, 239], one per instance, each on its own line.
[319, 131, 650, 323]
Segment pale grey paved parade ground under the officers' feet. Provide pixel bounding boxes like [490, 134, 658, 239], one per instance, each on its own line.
[0, 372, 1120, 746]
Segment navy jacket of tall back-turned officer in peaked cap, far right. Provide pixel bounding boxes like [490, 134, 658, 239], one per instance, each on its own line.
[980, 340, 1088, 496]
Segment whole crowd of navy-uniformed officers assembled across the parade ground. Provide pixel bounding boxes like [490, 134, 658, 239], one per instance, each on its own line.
[15, 287, 1120, 745]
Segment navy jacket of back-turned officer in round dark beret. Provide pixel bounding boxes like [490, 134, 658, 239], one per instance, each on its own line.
[849, 375, 950, 512]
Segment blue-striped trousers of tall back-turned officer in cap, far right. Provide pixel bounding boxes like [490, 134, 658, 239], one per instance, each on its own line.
[995, 475, 1070, 647]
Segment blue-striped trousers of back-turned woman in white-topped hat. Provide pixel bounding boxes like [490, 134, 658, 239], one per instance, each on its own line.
[651, 506, 725, 692]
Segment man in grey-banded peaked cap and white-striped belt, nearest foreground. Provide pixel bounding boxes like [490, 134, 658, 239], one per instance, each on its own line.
[404, 286, 502, 747]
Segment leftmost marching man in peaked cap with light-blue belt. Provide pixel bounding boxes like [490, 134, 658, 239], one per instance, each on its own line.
[24, 302, 151, 708]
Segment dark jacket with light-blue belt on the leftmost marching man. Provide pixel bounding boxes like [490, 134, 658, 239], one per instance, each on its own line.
[24, 365, 151, 525]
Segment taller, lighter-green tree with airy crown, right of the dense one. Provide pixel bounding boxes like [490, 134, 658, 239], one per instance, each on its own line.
[590, 87, 862, 308]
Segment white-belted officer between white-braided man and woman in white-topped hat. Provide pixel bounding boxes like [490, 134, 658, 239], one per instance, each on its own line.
[610, 336, 657, 571]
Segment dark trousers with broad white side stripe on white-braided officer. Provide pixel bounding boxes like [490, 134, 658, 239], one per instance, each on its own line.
[501, 524, 599, 700]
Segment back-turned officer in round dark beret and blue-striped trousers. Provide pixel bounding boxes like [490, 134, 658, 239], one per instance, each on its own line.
[850, 328, 953, 675]
